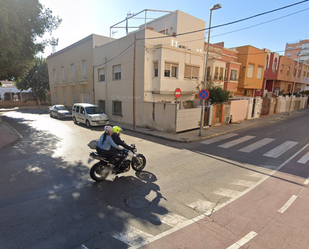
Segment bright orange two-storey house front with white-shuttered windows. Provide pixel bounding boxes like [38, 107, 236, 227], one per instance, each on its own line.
[235, 45, 266, 97]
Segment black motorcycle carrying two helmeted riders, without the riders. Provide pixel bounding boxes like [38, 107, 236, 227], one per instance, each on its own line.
[90, 144, 146, 182]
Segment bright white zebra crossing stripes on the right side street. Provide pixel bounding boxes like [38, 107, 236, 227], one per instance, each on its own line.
[200, 133, 309, 164]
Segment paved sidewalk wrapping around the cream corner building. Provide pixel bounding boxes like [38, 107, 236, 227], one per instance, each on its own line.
[111, 109, 309, 143]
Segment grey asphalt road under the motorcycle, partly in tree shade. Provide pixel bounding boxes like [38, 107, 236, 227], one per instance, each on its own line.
[0, 111, 309, 249]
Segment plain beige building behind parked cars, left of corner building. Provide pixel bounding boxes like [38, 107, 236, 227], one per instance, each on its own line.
[47, 34, 110, 106]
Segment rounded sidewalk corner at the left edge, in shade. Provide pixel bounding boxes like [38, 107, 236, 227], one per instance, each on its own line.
[0, 116, 22, 149]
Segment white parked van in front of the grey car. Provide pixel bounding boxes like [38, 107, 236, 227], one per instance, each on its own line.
[72, 103, 109, 127]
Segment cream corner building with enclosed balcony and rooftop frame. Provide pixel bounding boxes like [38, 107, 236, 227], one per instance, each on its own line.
[93, 10, 205, 127]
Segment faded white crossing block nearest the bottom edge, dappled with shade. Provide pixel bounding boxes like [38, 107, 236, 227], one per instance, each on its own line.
[112, 226, 153, 246]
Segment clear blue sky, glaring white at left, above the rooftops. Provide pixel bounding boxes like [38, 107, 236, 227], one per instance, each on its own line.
[40, 0, 309, 57]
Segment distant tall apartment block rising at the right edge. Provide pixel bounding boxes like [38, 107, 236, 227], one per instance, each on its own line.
[284, 39, 309, 62]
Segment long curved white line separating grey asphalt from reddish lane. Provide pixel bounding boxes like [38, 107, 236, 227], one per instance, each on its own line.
[129, 144, 309, 249]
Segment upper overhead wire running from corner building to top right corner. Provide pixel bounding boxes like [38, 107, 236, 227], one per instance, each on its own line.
[139, 0, 309, 40]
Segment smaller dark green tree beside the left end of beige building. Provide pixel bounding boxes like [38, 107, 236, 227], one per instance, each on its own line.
[16, 58, 49, 105]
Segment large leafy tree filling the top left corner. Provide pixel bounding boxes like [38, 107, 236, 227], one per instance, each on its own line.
[0, 0, 61, 80]
